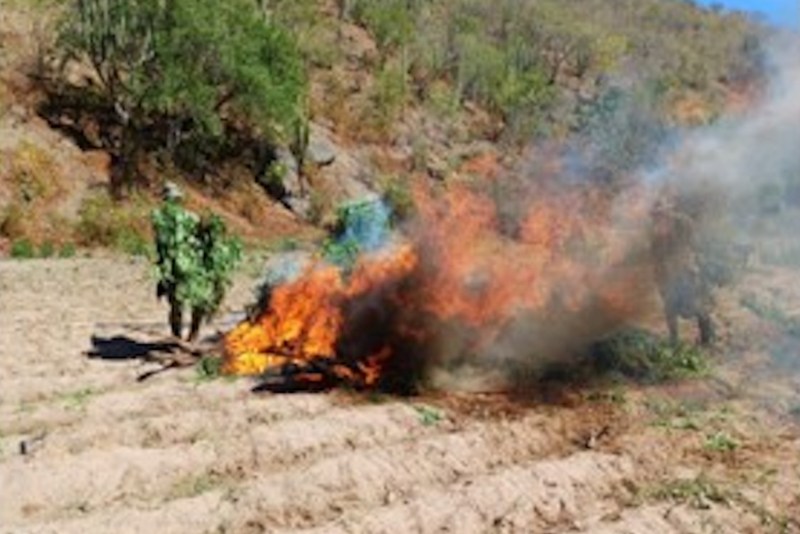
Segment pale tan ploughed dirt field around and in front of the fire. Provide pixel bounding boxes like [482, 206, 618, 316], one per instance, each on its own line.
[0, 259, 800, 534]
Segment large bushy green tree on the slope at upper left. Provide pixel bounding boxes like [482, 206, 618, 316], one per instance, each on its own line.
[59, 0, 306, 195]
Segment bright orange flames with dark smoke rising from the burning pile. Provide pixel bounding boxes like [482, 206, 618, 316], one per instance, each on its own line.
[219, 182, 639, 389]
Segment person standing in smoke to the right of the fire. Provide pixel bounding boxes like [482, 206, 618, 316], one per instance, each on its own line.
[651, 192, 716, 345]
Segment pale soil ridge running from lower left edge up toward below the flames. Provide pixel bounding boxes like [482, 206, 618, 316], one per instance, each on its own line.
[0, 404, 438, 522]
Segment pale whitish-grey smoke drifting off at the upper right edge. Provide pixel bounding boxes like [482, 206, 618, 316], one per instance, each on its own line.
[644, 34, 800, 278]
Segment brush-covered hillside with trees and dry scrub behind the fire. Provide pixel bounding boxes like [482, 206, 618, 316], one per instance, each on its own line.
[0, 0, 765, 254]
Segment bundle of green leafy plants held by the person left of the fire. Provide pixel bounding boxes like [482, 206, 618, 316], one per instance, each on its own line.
[152, 201, 241, 326]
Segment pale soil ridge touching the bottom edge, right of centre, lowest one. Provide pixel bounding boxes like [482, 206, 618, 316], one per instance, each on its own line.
[296, 452, 635, 534]
